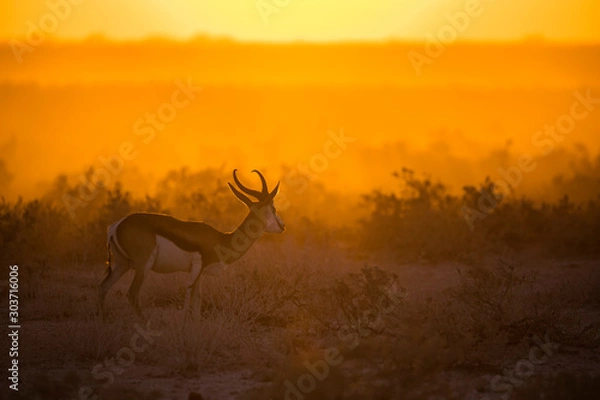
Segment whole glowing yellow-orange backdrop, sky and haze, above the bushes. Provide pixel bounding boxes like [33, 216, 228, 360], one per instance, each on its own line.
[0, 0, 600, 203]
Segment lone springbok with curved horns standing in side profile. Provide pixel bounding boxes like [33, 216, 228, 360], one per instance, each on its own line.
[98, 169, 285, 315]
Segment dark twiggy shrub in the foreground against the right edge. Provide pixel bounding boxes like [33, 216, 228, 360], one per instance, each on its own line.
[450, 259, 600, 346]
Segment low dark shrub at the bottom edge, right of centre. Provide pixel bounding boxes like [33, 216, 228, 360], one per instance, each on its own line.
[356, 293, 482, 398]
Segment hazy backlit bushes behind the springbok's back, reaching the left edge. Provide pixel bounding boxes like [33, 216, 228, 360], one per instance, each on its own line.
[0, 168, 240, 267]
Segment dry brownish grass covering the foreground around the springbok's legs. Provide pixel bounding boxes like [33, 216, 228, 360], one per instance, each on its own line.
[7, 239, 600, 399]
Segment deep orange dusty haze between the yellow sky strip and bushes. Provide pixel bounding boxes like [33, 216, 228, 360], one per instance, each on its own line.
[0, 40, 600, 203]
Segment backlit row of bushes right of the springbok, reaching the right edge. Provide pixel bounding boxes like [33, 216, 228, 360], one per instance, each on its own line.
[356, 169, 600, 262]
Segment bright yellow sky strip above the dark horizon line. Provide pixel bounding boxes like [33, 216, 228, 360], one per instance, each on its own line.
[0, 0, 600, 42]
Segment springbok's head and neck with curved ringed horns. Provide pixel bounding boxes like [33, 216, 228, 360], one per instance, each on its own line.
[227, 169, 285, 233]
